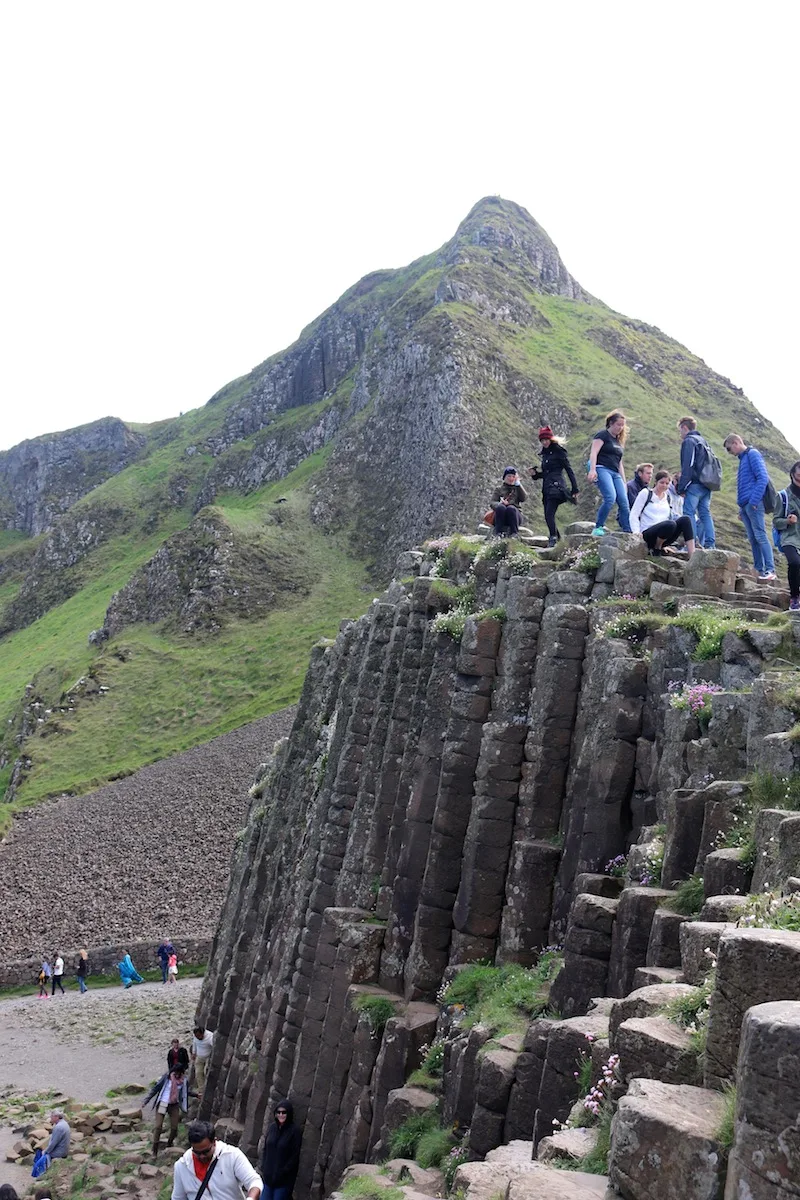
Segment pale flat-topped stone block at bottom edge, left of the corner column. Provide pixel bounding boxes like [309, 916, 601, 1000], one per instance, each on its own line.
[608, 1079, 727, 1200]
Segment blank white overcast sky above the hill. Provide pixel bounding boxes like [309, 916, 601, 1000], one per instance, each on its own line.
[0, 0, 800, 448]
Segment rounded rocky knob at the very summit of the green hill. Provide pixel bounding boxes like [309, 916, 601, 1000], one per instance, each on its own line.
[445, 196, 593, 301]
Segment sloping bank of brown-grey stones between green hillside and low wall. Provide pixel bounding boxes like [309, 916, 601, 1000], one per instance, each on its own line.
[0, 707, 295, 964]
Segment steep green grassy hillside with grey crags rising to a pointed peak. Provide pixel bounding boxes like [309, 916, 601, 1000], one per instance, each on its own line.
[0, 198, 796, 803]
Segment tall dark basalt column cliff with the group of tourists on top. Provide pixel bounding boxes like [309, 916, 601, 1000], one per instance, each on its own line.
[198, 535, 800, 1200]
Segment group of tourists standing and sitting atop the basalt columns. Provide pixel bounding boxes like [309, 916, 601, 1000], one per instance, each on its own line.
[483, 412, 800, 611]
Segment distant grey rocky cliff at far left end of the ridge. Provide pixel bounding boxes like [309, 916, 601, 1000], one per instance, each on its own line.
[0, 416, 146, 536]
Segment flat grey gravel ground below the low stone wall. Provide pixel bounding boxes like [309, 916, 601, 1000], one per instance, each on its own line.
[0, 979, 203, 1100]
